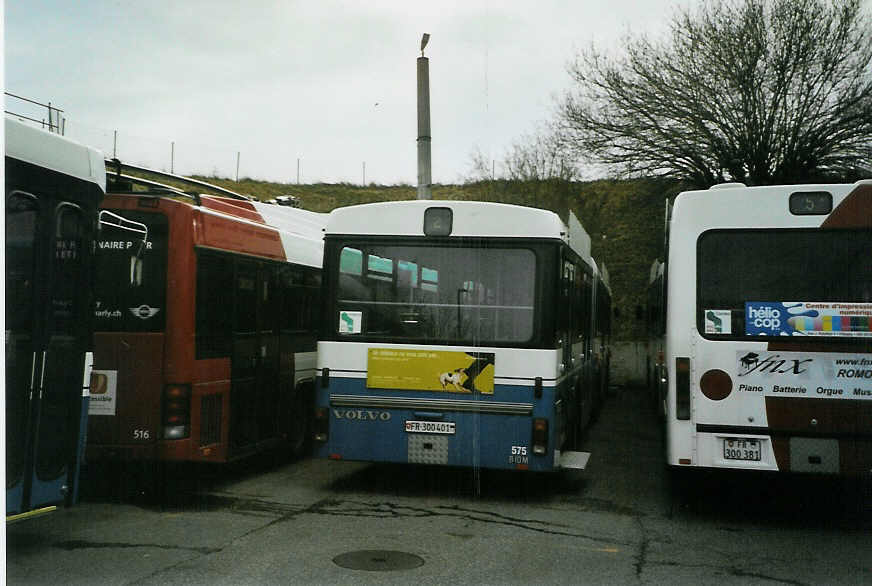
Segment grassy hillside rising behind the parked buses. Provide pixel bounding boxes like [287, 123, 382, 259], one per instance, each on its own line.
[124, 169, 680, 340]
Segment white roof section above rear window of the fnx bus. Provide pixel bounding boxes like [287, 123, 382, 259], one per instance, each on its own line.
[671, 180, 872, 233]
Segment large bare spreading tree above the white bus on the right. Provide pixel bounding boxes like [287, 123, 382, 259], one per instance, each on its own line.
[559, 0, 872, 187]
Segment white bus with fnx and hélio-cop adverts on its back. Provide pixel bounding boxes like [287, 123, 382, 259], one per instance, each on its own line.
[661, 181, 872, 474]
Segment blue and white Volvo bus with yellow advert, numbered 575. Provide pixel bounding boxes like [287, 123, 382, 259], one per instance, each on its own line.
[314, 200, 610, 471]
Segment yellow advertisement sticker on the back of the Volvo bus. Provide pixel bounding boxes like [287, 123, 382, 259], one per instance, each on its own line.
[366, 348, 494, 395]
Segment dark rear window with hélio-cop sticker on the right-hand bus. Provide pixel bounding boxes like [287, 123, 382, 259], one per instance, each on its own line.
[696, 230, 872, 337]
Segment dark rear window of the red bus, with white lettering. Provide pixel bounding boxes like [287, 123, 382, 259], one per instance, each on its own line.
[94, 210, 168, 332]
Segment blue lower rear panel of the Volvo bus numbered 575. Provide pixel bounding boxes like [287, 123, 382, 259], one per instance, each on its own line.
[316, 378, 556, 471]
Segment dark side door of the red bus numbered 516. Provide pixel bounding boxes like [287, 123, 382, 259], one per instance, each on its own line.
[230, 259, 280, 456]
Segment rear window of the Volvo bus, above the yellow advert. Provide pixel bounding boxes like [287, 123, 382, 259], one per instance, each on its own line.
[332, 244, 536, 344]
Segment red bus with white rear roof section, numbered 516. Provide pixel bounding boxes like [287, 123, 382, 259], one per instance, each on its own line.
[87, 176, 326, 470]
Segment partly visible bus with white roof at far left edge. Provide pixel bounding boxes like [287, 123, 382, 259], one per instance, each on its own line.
[5, 118, 106, 521]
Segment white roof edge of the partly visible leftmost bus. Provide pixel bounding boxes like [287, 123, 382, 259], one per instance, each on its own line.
[5, 116, 106, 187]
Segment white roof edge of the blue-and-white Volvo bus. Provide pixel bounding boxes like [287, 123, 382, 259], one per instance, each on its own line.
[326, 200, 590, 259]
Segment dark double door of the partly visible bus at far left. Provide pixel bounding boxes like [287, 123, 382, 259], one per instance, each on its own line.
[6, 191, 91, 515]
